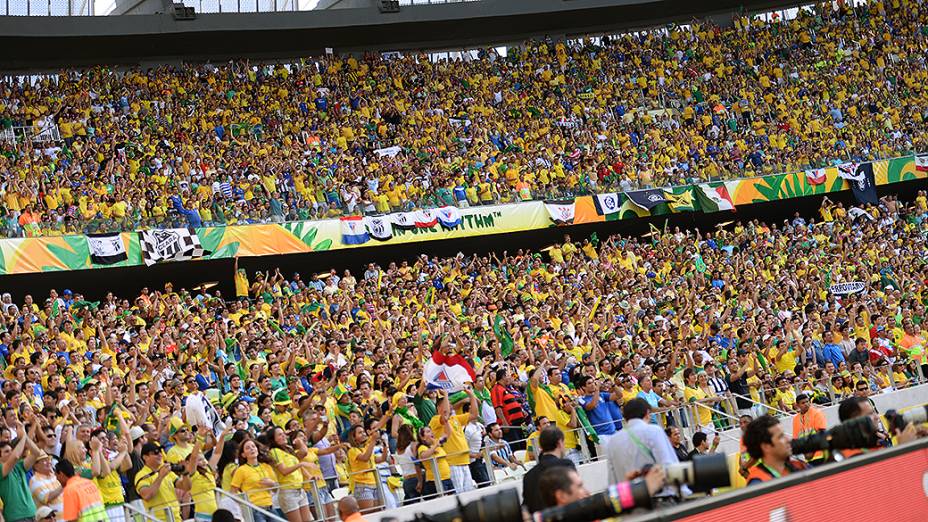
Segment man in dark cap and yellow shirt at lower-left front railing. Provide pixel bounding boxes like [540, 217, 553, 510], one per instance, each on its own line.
[135, 442, 192, 522]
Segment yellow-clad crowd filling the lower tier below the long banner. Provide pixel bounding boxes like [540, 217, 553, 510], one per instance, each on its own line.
[0, 192, 928, 522]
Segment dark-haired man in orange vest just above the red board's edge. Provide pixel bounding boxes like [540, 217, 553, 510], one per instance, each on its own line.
[744, 415, 806, 485]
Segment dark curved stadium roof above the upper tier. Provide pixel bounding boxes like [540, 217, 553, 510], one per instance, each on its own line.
[0, 0, 808, 71]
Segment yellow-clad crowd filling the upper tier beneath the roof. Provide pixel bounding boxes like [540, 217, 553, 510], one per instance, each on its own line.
[0, 0, 928, 236]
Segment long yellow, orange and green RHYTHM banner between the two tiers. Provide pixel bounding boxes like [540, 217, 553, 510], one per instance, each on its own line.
[0, 156, 928, 275]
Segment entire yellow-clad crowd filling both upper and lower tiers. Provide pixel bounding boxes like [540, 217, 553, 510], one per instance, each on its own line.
[0, 0, 928, 522]
